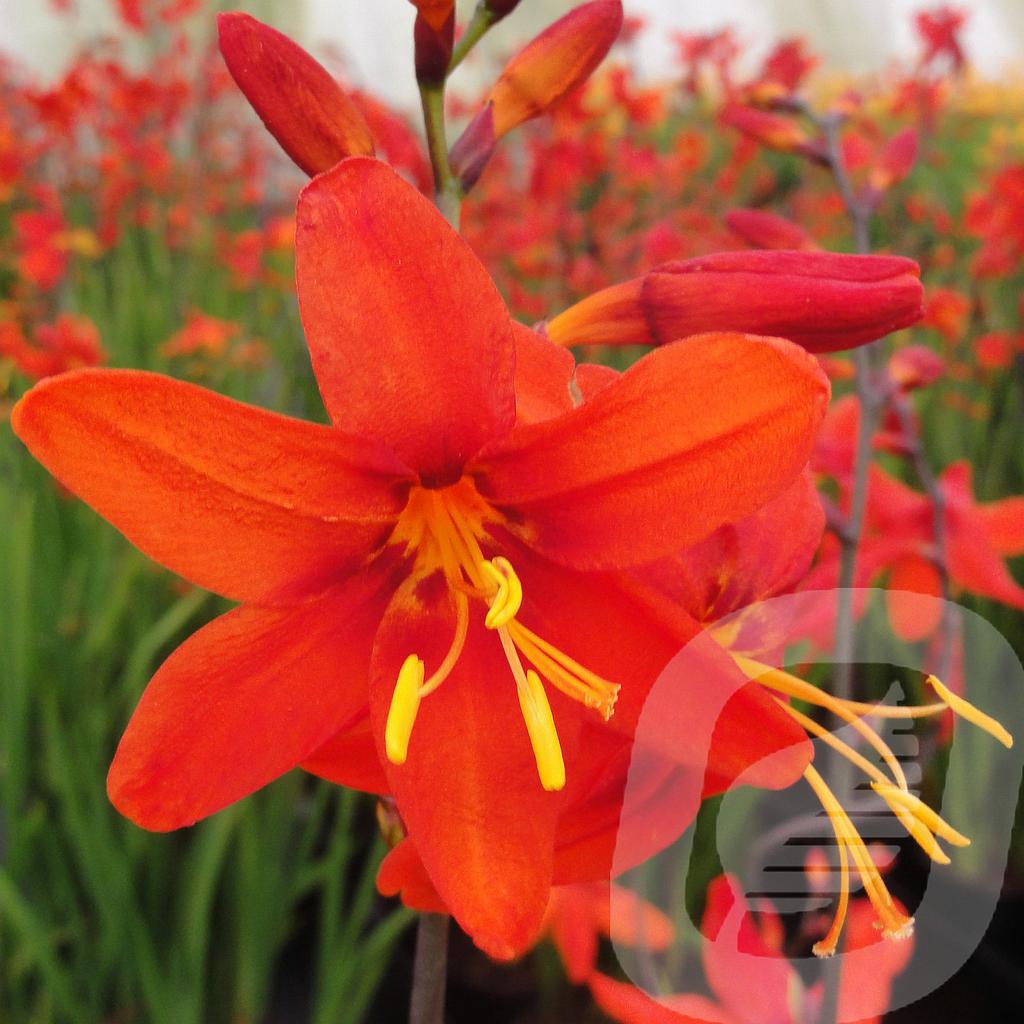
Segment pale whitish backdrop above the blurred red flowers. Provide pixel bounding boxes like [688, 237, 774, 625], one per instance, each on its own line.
[0, 0, 1024, 106]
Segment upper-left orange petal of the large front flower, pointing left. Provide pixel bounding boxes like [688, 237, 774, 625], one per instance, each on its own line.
[11, 370, 410, 602]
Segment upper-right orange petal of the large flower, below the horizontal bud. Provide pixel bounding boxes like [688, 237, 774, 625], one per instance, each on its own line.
[470, 335, 828, 569]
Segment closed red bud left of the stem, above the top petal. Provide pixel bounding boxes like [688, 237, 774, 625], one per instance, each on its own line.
[217, 11, 374, 176]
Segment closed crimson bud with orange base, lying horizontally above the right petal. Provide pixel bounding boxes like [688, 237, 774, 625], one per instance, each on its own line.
[547, 251, 923, 352]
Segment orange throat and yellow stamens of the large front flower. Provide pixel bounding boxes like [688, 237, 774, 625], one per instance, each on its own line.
[384, 477, 618, 791]
